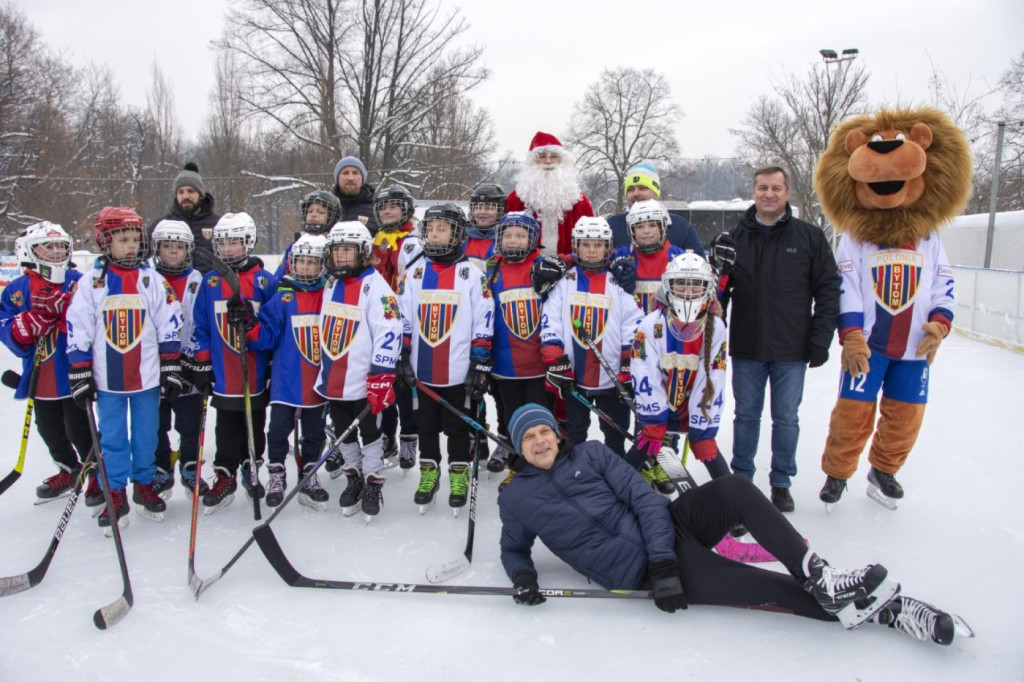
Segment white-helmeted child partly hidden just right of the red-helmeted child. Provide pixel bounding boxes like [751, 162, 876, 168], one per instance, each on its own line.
[151, 220, 210, 500]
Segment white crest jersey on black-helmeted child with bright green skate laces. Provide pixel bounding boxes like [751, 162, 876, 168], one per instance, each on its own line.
[398, 258, 495, 386]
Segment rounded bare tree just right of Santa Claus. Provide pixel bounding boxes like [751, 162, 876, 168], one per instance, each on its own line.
[566, 67, 682, 211]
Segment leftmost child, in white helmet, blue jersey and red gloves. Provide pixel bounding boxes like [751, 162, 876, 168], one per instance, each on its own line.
[0, 221, 94, 504]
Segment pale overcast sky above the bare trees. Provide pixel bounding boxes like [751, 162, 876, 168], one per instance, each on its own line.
[14, 0, 1024, 163]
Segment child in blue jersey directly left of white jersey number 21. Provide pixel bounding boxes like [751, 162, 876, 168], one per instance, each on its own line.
[246, 235, 330, 511]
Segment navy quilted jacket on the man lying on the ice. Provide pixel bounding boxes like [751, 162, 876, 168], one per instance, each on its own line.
[498, 440, 676, 590]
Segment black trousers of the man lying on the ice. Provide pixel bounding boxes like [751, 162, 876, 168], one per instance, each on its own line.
[669, 475, 837, 621]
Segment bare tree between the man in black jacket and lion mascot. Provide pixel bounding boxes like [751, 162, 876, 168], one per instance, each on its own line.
[730, 56, 870, 229]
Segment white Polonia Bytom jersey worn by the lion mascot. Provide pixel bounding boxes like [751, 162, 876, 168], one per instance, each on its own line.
[836, 235, 954, 360]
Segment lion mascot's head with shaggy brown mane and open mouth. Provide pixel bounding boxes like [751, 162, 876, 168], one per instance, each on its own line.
[814, 108, 971, 247]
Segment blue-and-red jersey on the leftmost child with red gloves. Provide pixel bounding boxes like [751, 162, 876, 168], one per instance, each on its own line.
[0, 269, 82, 400]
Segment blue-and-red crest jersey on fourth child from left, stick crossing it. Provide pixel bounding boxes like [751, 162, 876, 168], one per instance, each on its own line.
[191, 258, 278, 397]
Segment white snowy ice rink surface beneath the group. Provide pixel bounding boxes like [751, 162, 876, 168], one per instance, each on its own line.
[0, 329, 1024, 682]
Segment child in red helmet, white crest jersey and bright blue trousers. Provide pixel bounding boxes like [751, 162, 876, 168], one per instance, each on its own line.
[67, 206, 182, 527]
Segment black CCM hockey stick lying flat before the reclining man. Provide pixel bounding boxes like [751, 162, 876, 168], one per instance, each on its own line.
[253, 523, 653, 599]
